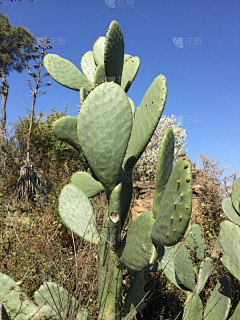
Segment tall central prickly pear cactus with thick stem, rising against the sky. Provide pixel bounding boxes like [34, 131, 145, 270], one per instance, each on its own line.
[44, 21, 194, 320]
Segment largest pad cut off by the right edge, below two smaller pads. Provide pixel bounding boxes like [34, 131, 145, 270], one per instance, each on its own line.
[218, 221, 240, 281]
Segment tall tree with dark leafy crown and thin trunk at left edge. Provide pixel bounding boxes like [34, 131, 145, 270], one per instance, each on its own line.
[0, 13, 36, 147]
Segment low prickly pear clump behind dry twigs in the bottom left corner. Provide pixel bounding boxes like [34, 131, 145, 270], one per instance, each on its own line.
[0, 273, 91, 320]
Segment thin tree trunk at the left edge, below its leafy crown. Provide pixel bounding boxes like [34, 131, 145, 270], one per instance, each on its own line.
[0, 71, 9, 147]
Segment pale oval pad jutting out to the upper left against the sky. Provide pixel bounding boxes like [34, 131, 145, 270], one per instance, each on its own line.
[44, 54, 93, 91]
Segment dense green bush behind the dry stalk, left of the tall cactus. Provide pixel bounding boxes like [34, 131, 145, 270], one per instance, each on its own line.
[5, 109, 88, 201]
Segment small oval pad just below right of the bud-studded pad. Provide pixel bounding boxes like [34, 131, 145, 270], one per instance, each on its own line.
[186, 224, 205, 260]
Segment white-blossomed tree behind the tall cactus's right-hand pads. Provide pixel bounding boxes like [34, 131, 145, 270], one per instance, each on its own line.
[135, 115, 187, 181]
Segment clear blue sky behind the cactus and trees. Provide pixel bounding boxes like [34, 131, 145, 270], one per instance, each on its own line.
[0, 0, 240, 173]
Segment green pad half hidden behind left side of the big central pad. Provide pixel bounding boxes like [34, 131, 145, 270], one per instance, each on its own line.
[53, 116, 81, 153]
